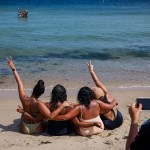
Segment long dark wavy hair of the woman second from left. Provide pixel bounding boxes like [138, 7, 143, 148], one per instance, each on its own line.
[50, 84, 67, 110]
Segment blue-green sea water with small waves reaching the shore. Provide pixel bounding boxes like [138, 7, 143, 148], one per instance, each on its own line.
[0, 4, 150, 88]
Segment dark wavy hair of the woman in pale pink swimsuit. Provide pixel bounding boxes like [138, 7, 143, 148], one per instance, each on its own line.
[77, 87, 94, 108]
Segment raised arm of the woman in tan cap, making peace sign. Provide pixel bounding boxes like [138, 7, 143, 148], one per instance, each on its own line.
[87, 61, 107, 93]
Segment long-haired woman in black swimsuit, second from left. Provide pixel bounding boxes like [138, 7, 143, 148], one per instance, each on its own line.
[46, 84, 73, 135]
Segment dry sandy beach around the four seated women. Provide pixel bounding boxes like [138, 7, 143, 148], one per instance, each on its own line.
[0, 87, 150, 150]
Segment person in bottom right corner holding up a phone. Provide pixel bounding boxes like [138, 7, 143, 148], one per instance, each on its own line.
[126, 103, 150, 150]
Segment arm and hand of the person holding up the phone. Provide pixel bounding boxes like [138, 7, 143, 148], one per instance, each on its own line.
[126, 103, 142, 150]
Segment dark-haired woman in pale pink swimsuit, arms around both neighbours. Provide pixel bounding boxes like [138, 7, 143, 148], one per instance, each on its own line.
[54, 87, 116, 136]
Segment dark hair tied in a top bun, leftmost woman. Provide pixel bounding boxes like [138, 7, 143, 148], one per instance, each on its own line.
[33, 80, 45, 97]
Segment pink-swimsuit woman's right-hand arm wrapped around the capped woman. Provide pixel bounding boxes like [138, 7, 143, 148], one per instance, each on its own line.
[97, 99, 117, 114]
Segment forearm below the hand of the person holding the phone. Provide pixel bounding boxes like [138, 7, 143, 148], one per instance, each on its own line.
[126, 122, 138, 150]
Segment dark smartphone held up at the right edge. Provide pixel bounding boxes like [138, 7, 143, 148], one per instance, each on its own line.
[136, 97, 150, 110]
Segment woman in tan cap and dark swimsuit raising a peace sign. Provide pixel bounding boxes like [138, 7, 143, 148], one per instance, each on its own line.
[87, 61, 123, 130]
